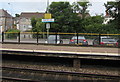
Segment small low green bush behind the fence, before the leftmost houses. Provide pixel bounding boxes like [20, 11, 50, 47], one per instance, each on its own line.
[6, 29, 20, 39]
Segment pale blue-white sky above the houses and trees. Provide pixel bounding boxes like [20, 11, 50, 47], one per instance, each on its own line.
[0, 0, 115, 16]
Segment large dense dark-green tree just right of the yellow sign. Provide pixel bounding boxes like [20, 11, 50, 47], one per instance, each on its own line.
[49, 2, 81, 32]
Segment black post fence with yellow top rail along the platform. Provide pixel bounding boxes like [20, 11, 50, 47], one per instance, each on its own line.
[1, 32, 120, 45]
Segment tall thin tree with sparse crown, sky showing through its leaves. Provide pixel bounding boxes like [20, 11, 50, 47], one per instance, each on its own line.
[72, 1, 91, 32]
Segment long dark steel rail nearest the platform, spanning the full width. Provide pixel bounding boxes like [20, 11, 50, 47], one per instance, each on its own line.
[2, 66, 120, 80]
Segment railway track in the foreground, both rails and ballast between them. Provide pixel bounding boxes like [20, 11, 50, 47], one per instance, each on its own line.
[2, 67, 120, 82]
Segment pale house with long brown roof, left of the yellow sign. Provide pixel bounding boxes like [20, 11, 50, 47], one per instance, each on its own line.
[15, 12, 44, 32]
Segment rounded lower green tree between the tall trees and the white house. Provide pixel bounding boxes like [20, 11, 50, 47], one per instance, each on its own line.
[82, 16, 103, 33]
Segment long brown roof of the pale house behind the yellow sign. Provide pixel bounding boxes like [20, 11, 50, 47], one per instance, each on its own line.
[20, 12, 44, 18]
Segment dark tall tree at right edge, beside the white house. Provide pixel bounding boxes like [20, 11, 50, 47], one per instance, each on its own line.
[104, 1, 120, 33]
